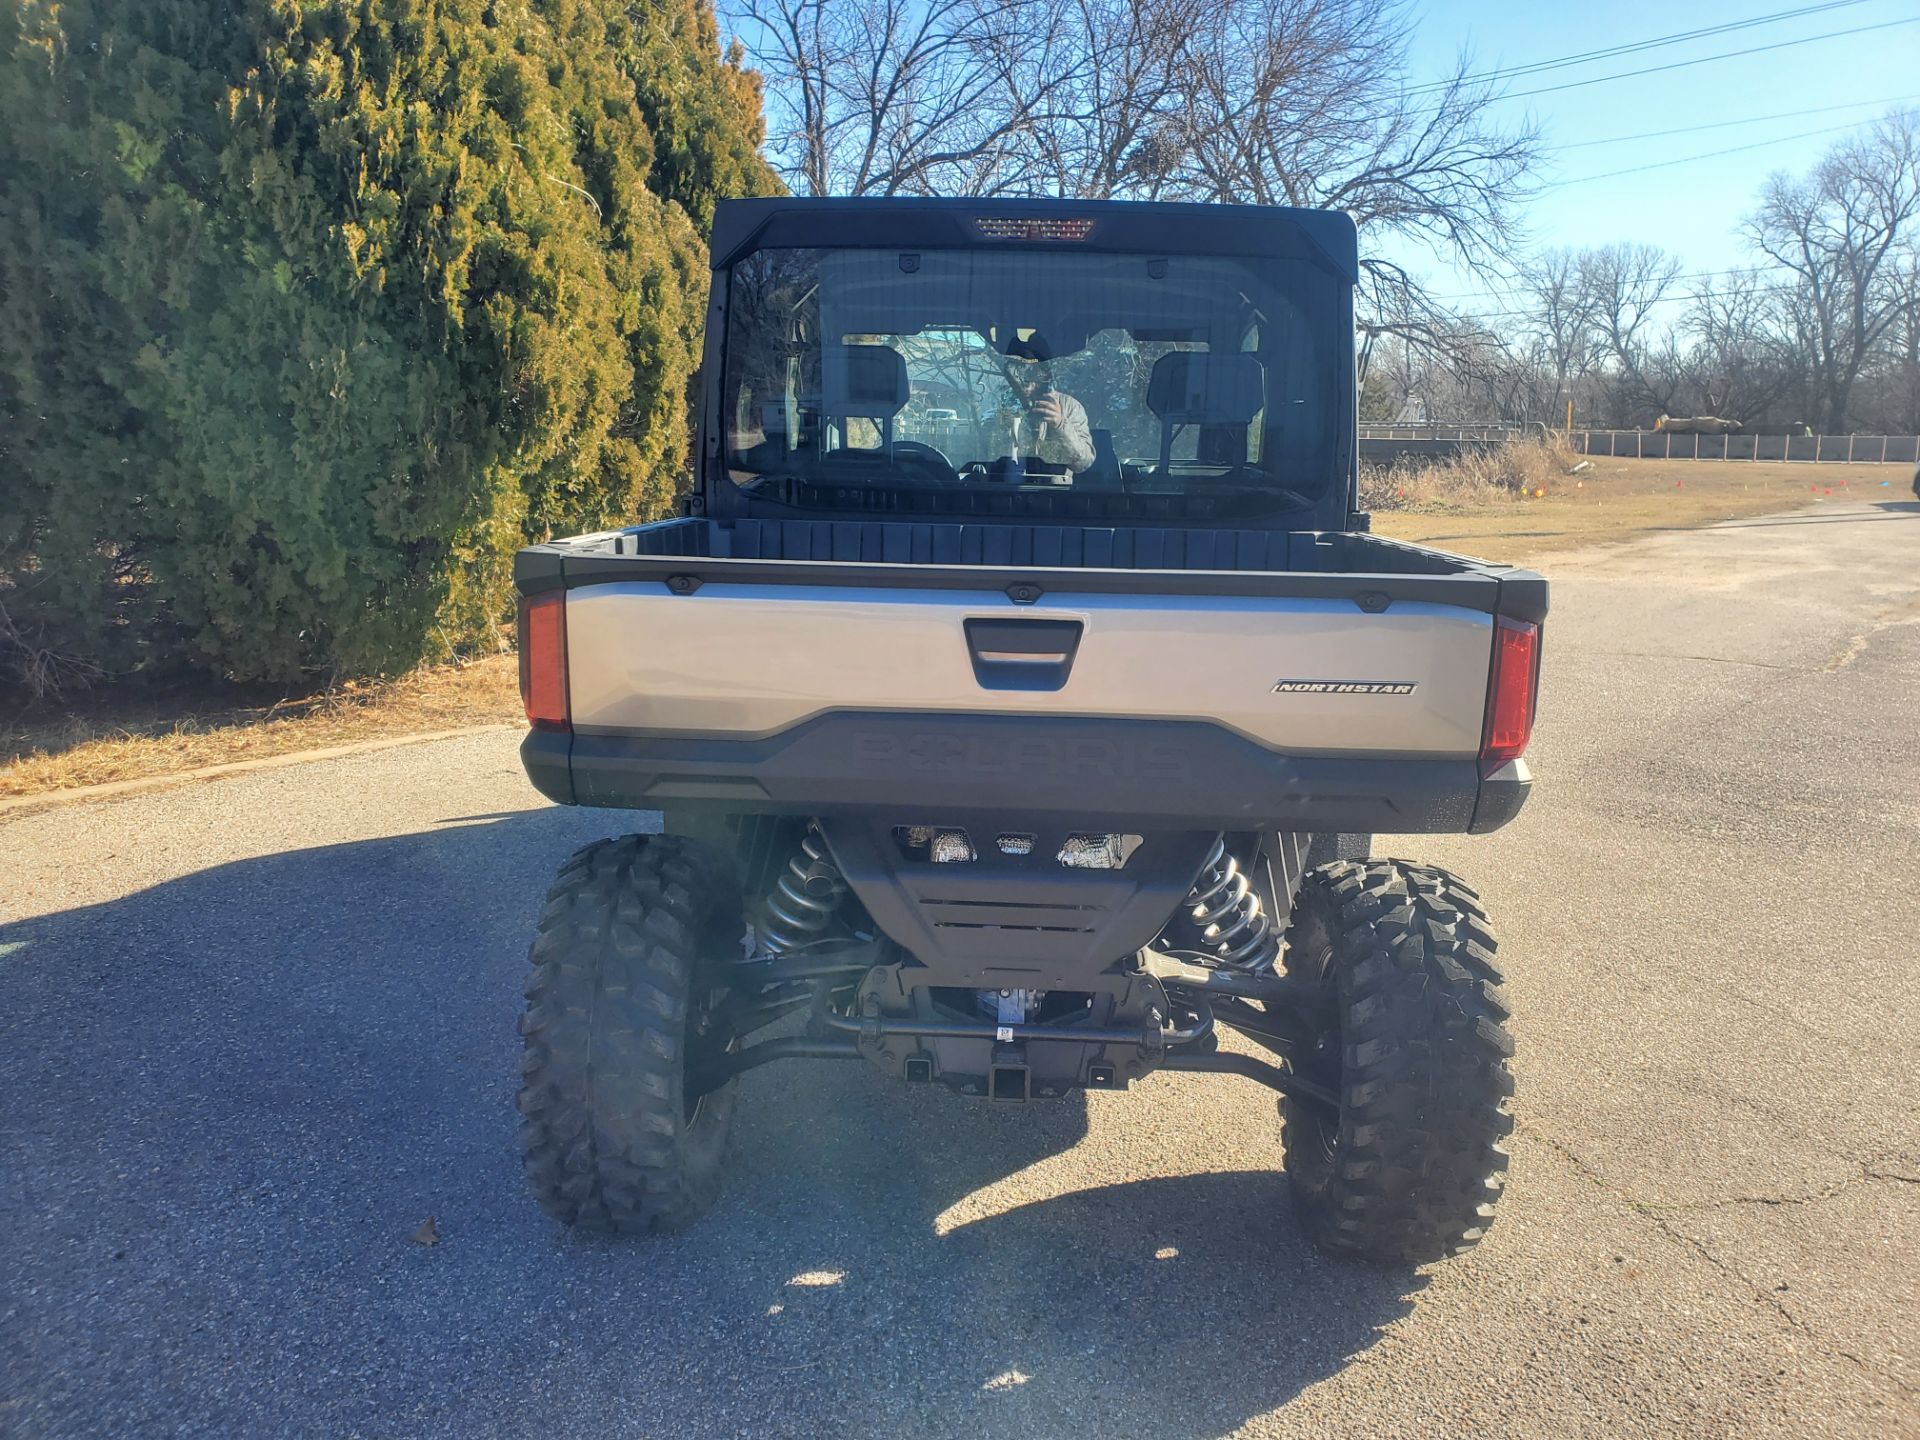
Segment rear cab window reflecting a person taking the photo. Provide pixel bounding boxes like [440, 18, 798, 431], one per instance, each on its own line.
[722, 250, 1350, 515]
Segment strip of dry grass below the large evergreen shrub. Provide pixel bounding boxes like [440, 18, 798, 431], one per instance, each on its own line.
[0, 655, 520, 797]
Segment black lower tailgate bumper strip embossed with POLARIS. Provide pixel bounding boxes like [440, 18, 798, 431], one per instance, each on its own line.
[520, 710, 1532, 833]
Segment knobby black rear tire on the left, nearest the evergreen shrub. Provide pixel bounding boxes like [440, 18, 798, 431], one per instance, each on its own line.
[520, 835, 743, 1233]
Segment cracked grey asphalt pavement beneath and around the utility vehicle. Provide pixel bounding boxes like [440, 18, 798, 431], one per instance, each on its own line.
[0, 503, 1920, 1436]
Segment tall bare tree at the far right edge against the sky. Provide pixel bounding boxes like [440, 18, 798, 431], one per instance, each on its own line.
[1747, 109, 1920, 432]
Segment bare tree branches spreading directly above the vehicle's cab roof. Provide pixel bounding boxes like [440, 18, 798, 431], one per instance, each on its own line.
[730, 0, 1538, 314]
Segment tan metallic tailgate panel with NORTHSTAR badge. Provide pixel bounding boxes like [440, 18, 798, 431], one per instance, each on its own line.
[566, 582, 1492, 758]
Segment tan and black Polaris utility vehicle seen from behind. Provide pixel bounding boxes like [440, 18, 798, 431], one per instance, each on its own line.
[515, 200, 1548, 1261]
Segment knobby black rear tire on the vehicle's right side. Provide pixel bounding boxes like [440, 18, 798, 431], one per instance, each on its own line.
[1281, 860, 1513, 1263]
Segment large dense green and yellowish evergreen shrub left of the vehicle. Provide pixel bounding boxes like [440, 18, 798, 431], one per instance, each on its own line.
[0, 0, 772, 698]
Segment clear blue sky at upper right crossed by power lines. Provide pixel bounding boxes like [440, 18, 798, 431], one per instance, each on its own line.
[1394, 0, 1920, 311]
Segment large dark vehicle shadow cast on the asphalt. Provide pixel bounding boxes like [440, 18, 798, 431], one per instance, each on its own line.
[0, 810, 1421, 1436]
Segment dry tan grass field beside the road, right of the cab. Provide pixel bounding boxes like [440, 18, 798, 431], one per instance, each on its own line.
[1361, 444, 1912, 561]
